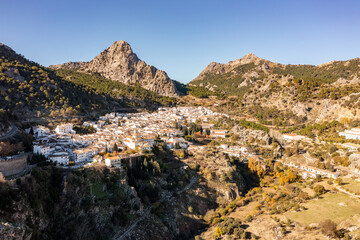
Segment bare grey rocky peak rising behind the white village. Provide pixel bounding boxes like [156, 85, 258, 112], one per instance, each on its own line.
[50, 41, 178, 96]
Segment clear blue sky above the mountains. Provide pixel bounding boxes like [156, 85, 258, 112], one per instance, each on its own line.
[0, 0, 360, 83]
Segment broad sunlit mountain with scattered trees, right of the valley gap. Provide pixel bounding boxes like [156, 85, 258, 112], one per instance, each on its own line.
[188, 53, 360, 121]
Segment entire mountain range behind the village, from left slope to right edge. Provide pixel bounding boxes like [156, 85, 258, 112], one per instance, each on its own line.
[0, 41, 360, 122]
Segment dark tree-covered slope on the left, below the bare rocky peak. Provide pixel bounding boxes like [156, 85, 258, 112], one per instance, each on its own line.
[0, 44, 176, 122]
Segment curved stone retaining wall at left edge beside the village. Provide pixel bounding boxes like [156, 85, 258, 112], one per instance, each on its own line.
[0, 153, 29, 177]
